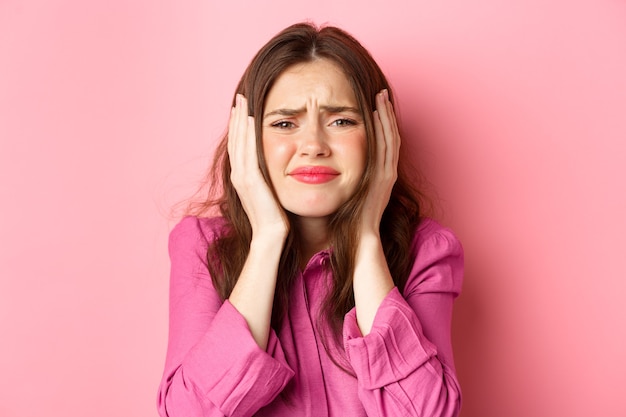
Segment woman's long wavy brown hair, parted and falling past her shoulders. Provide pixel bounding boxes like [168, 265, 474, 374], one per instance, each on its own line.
[191, 23, 420, 360]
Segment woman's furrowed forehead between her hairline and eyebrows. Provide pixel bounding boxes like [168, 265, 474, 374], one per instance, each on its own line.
[265, 59, 357, 110]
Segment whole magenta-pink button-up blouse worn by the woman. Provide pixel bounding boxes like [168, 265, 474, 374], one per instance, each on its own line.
[158, 217, 463, 417]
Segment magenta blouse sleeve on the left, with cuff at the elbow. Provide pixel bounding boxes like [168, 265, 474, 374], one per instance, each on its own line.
[157, 217, 293, 417]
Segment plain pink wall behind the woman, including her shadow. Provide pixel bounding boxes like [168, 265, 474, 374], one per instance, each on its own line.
[0, 0, 626, 417]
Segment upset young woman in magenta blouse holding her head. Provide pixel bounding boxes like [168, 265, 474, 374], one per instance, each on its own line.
[158, 24, 463, 417]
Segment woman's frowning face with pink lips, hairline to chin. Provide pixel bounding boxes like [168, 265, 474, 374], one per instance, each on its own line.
[263, 59, 367, 217]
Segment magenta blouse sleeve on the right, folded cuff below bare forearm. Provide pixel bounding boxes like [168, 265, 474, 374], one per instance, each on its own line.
[344, 220, 463, 417]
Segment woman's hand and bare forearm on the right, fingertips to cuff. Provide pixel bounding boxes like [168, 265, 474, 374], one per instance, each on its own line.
[353, 90, 400, 336]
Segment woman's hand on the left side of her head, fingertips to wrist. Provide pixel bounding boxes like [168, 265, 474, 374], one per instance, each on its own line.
[228, 94, 289, 237]
